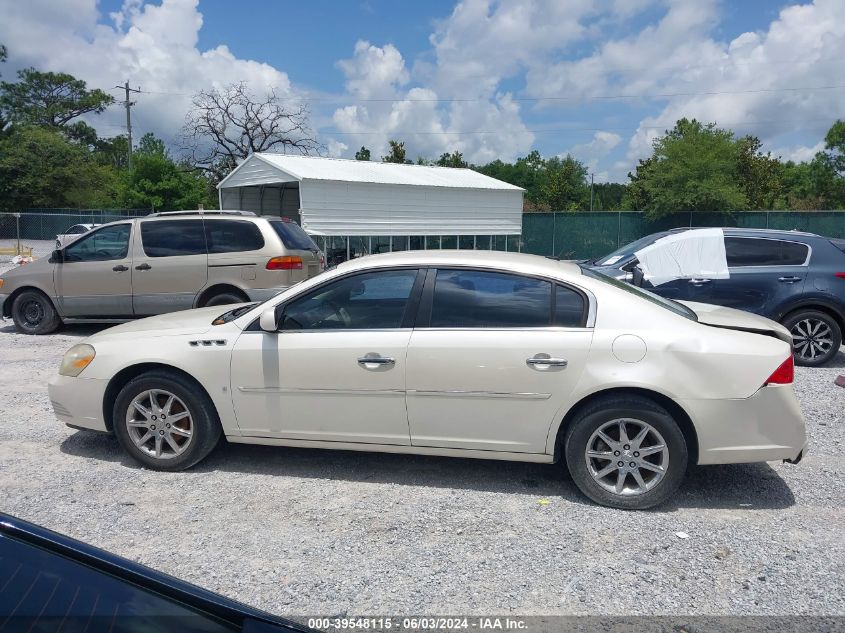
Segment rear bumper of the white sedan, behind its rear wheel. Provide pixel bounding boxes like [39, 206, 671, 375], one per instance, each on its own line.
[679, 385, 807, 464]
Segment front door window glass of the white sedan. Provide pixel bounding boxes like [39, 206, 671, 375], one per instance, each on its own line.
[281, 270, 417, 330]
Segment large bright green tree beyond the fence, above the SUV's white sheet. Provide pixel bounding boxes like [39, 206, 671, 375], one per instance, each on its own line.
[628, 119, 748, 218]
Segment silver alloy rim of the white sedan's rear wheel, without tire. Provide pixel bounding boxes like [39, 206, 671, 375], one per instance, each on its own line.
[584, 418, 669, 496]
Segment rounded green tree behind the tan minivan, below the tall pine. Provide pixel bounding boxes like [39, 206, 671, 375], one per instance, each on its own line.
[0, 125, 117, 210]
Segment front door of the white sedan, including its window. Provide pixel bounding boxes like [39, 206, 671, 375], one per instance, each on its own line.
[231, 269, 422, 445]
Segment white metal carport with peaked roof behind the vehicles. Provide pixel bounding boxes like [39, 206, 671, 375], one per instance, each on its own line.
[217, 153, 524, 236]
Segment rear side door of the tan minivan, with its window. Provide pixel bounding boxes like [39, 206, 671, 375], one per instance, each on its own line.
[132, 218, 208, 316]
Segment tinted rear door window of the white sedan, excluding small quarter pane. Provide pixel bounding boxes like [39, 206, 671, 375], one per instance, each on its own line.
[431, 269, 552, 328]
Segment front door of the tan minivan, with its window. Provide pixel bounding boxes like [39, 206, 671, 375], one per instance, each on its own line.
[55, 222, 132, 317]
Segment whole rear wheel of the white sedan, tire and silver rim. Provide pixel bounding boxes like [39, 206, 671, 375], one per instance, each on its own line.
[563, 396, 688, 510]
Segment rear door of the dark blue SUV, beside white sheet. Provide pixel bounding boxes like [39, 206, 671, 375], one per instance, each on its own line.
[686, 236, 810, 316]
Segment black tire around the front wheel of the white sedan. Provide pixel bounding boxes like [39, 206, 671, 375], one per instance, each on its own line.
[112, 370, 221, 471]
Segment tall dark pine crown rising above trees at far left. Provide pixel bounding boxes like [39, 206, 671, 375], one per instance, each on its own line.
[0, 68, 114, 137]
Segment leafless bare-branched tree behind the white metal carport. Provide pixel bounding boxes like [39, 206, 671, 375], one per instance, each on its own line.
[182, 82, 325, 179]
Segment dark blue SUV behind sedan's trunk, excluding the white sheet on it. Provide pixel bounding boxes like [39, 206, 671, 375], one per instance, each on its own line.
[587, 228, 845, 366]
